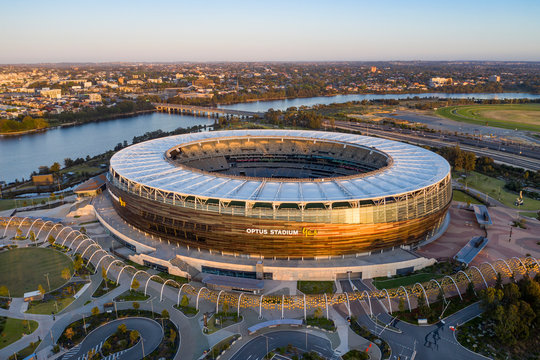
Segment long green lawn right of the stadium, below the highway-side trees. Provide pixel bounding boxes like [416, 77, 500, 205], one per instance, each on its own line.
[458, 171, 540, 211]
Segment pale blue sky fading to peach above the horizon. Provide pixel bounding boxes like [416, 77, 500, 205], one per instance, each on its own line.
[0, 0, 540, 64]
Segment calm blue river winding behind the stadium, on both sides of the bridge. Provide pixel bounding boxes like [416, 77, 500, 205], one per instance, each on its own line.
[0, 93, 540, 182]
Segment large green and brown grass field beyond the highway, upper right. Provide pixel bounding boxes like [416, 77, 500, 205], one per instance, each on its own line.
[435, 104, 540, 131]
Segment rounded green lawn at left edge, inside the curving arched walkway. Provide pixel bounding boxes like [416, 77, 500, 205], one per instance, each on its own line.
[0, 248, 73, 297]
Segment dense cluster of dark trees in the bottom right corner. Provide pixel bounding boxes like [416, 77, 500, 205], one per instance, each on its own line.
[480, 274, 540, 348]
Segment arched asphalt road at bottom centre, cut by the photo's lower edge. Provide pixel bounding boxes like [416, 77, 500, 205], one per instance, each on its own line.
[231, 330, 338, 360]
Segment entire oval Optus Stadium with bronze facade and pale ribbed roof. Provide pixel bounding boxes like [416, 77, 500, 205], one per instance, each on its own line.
[108, 130, 452, 259]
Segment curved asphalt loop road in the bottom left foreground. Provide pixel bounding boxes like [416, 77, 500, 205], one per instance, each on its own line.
[62, 318, 163, 360]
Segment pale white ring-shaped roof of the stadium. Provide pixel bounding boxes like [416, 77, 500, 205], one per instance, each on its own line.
[111, 130, 450, 203]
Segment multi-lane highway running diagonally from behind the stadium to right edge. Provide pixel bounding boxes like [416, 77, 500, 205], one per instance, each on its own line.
[335, 121, 540, 171]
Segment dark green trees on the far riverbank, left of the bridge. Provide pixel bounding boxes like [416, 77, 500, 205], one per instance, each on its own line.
[50, 99, 154, 124]
